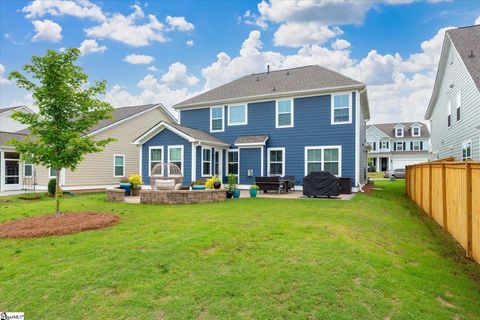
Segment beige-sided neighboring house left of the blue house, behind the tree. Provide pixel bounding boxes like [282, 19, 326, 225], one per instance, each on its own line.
[0, 104, 176, 190]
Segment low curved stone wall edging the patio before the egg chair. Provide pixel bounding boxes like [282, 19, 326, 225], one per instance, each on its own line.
[140, 189, 226, 204]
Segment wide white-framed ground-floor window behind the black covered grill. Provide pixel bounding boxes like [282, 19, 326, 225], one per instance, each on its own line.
[305, 146, 342, 176]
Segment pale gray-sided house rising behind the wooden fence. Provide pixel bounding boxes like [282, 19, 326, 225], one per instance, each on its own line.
[425, 25, 480, 160]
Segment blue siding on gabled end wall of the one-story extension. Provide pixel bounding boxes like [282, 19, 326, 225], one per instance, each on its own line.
[142, 129, 192, 186]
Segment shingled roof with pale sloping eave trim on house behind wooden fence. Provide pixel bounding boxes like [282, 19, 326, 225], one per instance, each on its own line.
[425, 25, 480, 120]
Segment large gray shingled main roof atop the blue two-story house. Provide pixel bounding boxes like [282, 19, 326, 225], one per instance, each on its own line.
[174, 65, 369, 119]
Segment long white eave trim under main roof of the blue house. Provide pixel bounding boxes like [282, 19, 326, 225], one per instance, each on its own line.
[173, 84, 365, 110]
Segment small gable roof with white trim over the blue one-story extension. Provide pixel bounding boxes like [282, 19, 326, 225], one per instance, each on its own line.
[132, 121, 229, 147]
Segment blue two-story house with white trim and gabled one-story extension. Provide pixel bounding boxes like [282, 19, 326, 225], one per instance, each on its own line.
[134, 66, 370, 188]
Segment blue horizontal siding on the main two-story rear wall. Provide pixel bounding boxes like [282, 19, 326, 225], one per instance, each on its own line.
[181, 93, 356, 184]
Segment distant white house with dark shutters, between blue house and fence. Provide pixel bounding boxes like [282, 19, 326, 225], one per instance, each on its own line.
[367, 122, 430, 171]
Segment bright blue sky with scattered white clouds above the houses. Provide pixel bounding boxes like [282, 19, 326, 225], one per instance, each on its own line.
[0, 0, 480, 122]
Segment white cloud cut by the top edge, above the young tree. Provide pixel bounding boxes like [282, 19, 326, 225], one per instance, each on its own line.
[22, 0, 105, 21]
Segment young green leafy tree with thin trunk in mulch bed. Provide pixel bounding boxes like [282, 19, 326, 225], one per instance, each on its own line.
[8, 49, 112, 216]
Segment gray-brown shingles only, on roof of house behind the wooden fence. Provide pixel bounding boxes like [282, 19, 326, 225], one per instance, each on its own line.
[447, 25, 480, 90]
